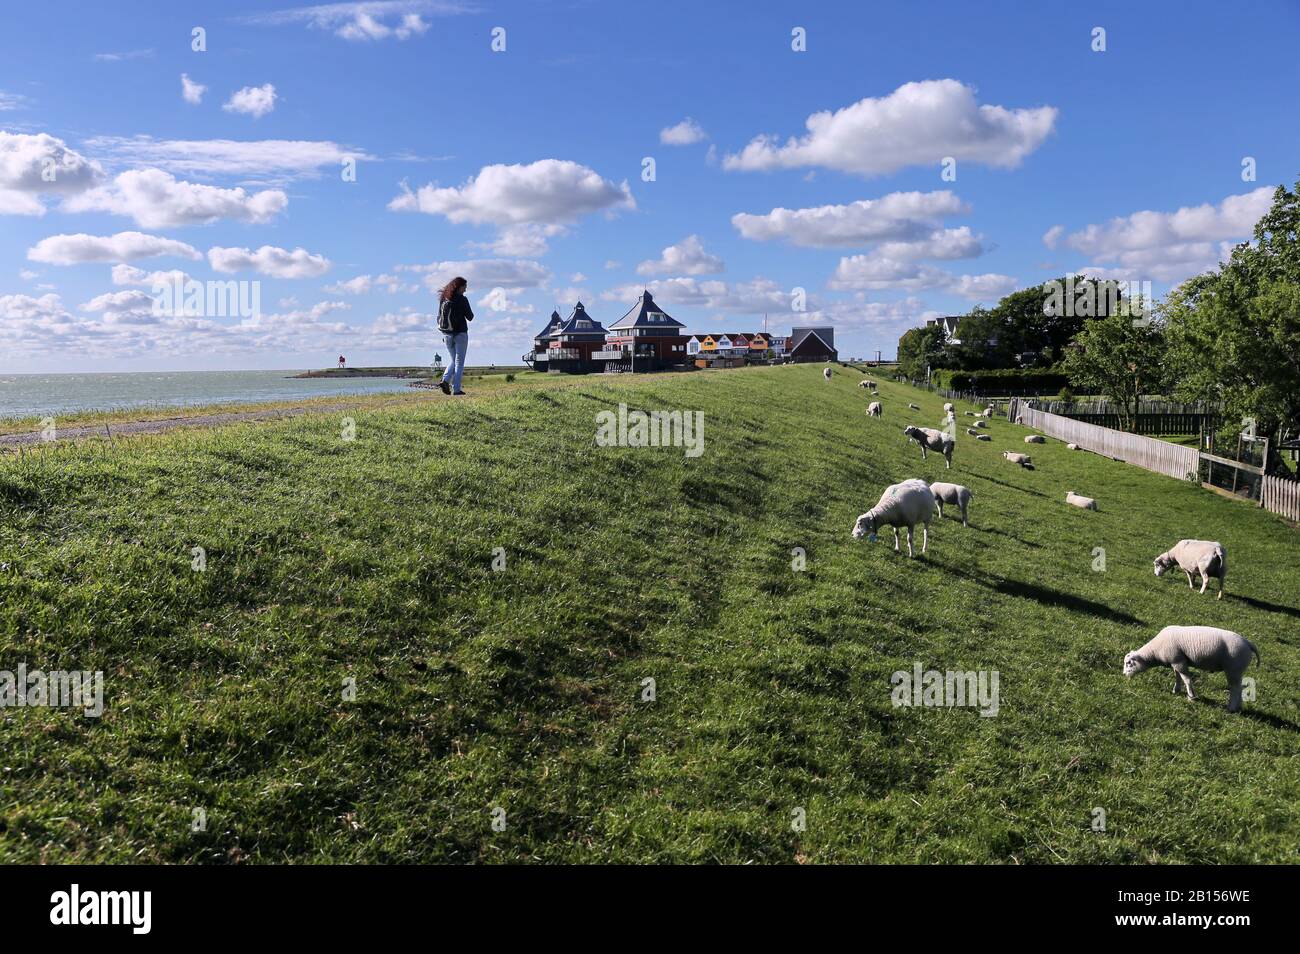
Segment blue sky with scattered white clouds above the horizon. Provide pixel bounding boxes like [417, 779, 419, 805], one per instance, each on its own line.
[0, 0, 1300, 372]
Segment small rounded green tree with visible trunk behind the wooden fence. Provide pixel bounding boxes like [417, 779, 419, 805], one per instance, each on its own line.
[1062, 308, 1167, 430]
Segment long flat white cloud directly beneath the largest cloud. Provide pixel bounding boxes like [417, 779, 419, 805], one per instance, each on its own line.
[732, 190, 970, 248]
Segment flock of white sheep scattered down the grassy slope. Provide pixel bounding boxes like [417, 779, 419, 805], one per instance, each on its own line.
[842, 368, 1260, 712]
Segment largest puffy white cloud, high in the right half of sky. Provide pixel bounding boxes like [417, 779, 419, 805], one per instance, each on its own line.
[723, 79, 1057, 175]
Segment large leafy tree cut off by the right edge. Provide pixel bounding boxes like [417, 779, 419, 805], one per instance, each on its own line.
[1161, 182, 1300, 467]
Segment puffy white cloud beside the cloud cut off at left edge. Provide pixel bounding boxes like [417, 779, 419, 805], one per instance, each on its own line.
[64, 169, 289, 229]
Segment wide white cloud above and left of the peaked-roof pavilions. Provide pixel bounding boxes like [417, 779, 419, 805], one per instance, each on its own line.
[389, 159, 636, 227]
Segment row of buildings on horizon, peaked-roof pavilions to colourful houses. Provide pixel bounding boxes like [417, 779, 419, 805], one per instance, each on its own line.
[524, 291, 839, 374]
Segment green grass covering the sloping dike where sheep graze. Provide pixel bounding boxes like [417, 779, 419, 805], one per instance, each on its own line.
[0, 365, 1300, 863]
